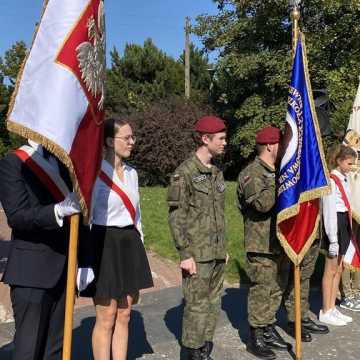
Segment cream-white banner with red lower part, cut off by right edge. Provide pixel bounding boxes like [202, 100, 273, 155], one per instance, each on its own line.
[344, 85, 360, 270]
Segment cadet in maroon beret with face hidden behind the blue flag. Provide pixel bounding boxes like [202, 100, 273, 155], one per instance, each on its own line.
[237, 127, 289, 359]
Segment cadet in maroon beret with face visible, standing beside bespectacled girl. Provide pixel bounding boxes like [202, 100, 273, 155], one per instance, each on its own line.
[167, 116, 227, 360]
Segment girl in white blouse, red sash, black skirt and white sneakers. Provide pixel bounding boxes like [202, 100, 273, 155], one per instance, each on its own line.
[319, 145, 356, 326]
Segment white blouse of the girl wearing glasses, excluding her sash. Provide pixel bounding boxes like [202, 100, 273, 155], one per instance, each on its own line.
[91, 160, 144, 241]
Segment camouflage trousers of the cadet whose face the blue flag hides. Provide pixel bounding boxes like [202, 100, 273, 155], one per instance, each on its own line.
[246, 253, 283, 328]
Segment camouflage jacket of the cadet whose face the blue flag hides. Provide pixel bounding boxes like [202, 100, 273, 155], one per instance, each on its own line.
[237, 157, 281, 254]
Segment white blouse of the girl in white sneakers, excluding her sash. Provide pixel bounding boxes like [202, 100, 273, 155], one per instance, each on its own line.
[322, 170, 350, 243]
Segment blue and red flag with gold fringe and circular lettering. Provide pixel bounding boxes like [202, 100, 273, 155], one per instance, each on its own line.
[277, 33, 329, 265]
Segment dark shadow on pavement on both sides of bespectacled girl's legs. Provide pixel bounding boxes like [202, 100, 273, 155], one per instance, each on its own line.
[72, 310, 154, 360]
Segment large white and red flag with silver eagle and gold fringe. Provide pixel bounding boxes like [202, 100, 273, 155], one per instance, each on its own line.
[7, 0, 106, 219]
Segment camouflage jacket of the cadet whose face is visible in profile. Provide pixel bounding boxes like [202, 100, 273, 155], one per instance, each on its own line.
[167, 154, 226, 261]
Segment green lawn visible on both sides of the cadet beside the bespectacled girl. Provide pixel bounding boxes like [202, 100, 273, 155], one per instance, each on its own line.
[140, 182, 246, 282]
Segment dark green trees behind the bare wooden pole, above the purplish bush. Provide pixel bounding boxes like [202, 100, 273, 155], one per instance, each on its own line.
[106, 39, 210, 112]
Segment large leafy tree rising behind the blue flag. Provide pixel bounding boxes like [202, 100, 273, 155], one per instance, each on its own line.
[195, 0, 360, 163]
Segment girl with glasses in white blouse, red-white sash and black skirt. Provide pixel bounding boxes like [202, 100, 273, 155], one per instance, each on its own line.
[91, 119, 153, 360]
